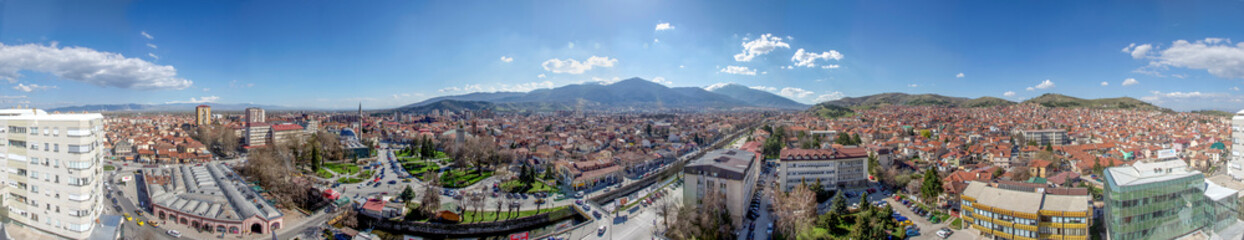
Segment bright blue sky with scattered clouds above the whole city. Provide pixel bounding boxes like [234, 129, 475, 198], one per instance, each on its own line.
[0, 0, 1244, 109]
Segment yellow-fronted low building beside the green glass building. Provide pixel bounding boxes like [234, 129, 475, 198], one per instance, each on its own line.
[959, 182, 1092, 239]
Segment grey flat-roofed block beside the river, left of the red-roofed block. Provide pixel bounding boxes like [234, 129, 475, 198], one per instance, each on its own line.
[683, 149, 760, 228]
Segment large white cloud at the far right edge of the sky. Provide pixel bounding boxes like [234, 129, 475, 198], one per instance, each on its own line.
[1123, 37, 1244, 78]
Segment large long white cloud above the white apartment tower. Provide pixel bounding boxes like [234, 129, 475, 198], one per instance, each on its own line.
[0, 44, 193, 90]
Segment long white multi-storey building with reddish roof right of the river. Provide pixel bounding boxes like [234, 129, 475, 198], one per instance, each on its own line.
[779, 148, 868, 192]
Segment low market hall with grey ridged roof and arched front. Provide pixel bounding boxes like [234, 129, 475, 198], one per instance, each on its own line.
[142, 163, 285, 235]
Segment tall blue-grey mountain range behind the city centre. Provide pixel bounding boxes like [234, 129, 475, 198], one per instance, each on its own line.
[394, 78, 809, 113]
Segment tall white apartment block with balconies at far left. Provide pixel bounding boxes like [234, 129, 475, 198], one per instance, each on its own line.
[0, 109, 104, 239]
